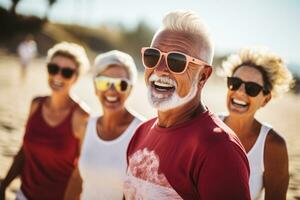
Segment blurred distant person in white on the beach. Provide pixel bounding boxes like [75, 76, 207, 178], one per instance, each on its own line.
[17, 35, 37, 78]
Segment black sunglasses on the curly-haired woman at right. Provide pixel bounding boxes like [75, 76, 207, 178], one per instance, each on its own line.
[227, 77, 269, 97]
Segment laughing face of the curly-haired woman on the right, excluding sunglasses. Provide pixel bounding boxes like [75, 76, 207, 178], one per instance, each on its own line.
[227, 66, 271, 116]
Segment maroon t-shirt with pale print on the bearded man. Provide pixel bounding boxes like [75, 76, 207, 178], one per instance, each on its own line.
[124, 111, 250, 200]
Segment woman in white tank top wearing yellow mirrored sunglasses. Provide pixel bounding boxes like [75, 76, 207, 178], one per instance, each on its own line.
[65, 50, 141, 200]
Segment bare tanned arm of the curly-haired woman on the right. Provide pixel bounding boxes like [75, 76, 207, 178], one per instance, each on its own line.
[264, 130, 289, 200]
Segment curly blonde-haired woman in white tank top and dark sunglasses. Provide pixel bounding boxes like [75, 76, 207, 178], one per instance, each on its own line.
[220, 47, 292, 200]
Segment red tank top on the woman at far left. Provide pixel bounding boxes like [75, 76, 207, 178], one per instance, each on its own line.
[21, 97, 79, 200]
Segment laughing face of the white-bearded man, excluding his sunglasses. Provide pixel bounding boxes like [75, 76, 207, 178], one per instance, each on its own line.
[145, 30, 210, 111]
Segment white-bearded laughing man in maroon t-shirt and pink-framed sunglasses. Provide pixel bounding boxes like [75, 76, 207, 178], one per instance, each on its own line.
[124, 11, 250, 200]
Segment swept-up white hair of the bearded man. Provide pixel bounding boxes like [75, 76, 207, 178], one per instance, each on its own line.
[152, 10, 214, 64]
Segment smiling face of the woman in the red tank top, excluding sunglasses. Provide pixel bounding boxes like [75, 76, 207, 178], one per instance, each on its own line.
[48, 55, 78, 93]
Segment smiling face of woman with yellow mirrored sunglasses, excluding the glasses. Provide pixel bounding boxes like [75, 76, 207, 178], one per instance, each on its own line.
[95, 64, 132, 111]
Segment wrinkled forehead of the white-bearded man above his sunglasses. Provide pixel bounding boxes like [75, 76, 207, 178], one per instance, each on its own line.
[151, 30, 207, 60]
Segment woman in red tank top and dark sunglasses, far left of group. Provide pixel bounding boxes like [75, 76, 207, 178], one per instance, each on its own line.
[0, 42, 89, 200]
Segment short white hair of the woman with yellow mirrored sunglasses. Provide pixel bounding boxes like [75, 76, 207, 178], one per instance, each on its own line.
[93, 50, 137, 84]
